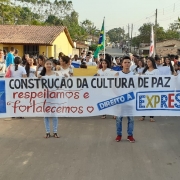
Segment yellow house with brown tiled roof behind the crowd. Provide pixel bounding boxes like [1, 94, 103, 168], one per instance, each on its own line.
[0, 25, 75, 58]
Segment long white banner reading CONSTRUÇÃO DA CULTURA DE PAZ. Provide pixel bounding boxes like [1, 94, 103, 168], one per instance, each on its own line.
[0, 76, 180, 117]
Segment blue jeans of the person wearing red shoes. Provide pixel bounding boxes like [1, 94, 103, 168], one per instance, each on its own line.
[116, 116, 134, 136]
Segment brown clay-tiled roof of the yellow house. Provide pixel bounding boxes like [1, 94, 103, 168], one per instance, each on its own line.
[0, 25, 74, 47]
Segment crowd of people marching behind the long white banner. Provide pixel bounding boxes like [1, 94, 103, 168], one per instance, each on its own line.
[0, 47, 180, 142]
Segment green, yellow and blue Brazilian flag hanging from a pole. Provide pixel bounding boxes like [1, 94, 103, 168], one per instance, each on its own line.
[94, 20, 105, 58]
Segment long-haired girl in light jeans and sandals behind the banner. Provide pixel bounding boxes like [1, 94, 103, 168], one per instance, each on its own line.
[38, 60, 59, 138]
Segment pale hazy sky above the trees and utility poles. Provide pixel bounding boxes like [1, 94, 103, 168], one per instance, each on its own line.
[72, 0, 180, 36]
